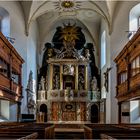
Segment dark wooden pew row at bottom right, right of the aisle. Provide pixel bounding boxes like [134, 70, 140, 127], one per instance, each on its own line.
[84, 124, 140, 139]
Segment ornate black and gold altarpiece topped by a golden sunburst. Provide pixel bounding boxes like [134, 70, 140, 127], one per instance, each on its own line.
[37, 24, 100, 121]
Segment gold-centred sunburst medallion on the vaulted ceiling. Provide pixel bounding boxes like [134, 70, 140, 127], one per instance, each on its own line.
[53, 0, 81, 12]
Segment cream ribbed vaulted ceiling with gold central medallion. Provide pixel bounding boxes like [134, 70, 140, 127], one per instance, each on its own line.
[20, 0, 117, 34]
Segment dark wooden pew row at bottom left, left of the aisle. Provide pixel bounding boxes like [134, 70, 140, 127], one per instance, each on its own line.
[0, 123, 54, 139]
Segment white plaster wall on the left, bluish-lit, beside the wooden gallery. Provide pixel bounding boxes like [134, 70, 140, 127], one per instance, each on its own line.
[0, 1, 37, 116]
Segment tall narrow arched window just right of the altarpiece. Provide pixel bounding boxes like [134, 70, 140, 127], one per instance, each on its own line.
[101, 31, 106, 68]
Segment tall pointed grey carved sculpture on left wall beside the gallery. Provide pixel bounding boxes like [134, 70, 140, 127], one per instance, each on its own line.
[26, 71, 36, 114]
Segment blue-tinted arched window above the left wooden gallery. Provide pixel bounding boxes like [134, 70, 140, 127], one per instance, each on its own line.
[0, 7, 10, 37]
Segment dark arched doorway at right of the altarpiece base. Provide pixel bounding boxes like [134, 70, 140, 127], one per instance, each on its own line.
[91, 104, 99, 123]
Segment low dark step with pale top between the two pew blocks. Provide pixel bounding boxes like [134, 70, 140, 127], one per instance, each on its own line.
[54, 128, 84, 139]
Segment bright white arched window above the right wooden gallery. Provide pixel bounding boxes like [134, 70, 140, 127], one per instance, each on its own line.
[128, 4, 140, 39]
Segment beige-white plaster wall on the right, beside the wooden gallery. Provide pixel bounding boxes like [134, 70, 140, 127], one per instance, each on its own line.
[110, 1, 138, 123]
